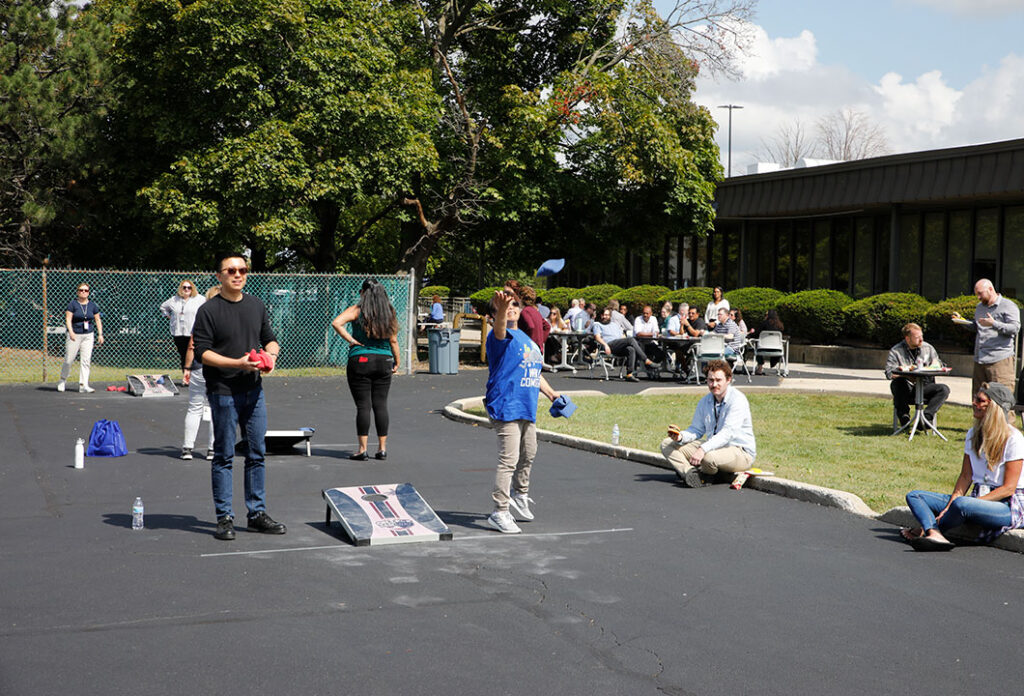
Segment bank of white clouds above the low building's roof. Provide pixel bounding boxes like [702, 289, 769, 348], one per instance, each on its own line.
[694, 26, 1024, 174]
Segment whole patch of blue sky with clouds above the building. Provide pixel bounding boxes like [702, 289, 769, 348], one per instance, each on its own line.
[655, 0, 1024, 174]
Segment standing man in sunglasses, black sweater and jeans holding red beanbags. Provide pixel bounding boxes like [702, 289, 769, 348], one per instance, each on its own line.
[193, 254, 286, 540]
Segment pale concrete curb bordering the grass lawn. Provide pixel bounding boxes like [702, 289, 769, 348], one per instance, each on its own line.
[442, 387, 1024, 554]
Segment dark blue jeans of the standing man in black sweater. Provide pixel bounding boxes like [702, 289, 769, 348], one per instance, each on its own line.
[207, 387, 266, 519]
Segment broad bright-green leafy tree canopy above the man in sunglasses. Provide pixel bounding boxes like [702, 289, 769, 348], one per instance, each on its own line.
[105, 0, 438, 271]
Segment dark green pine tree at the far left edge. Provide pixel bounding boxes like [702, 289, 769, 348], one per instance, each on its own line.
[0, 0, 110, 266]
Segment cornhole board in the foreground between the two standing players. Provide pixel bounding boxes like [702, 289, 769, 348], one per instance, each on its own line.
[323, 483, 452, 547]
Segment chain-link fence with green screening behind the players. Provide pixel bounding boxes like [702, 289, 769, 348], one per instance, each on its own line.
[0, 269, 416, 382]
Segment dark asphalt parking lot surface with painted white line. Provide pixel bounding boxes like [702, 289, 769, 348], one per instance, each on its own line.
[0, 371, 1024, 696]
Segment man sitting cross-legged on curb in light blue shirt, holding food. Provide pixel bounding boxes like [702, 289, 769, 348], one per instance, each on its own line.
[662, 360, 757, 488]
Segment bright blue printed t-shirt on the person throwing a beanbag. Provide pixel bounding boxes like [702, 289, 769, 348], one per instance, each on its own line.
[484, 329, 544, 422]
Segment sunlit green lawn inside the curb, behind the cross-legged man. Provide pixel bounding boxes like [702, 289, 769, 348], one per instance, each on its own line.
[478, 393, 972, 512]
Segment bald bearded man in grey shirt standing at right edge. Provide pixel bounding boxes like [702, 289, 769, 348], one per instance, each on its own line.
[952, 278, 1021, 394]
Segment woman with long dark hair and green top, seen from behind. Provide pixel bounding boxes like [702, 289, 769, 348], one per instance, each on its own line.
[331, 278, 400, 462]
